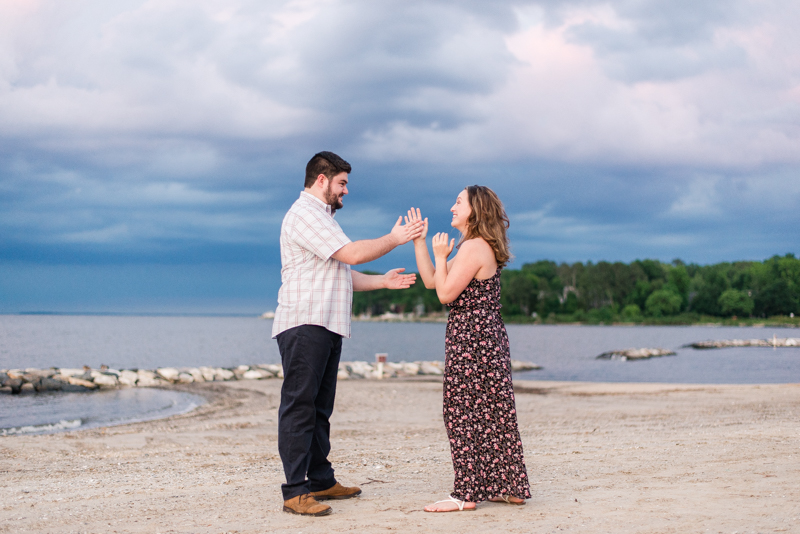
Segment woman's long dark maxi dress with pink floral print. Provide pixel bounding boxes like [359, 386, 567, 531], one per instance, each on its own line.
[443, 269, 531, 502]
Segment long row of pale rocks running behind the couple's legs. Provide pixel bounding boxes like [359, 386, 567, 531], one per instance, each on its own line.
[0, 360, 541, 393]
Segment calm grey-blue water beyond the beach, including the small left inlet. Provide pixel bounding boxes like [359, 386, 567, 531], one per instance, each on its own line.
[0, 315, 800, 433]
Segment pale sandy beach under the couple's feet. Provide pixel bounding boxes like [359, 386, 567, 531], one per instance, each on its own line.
[0, 379, 800, 533]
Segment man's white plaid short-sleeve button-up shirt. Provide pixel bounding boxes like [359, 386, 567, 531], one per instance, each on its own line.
[272, 191, 353, 338]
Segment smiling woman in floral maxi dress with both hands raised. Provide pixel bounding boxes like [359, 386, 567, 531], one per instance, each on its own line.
[406, 185, 530, 512]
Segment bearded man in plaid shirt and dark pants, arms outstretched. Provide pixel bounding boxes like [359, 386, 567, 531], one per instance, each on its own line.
[272, 152, 422, 516]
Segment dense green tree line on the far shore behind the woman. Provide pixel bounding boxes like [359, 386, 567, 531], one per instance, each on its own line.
[353, 254, 800, 323]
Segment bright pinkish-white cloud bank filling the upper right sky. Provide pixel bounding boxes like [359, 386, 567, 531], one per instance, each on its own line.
[364, 2, 800, 169]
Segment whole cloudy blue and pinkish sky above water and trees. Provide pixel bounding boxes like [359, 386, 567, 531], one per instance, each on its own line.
[0, 0, 800, 314]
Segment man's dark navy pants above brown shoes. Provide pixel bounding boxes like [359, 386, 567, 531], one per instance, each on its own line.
[277, 325, 342, 500]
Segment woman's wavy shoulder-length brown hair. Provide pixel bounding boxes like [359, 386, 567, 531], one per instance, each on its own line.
[462, 185, 512, 269]
